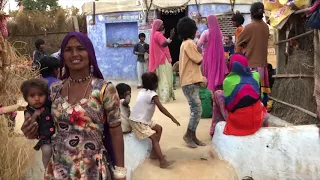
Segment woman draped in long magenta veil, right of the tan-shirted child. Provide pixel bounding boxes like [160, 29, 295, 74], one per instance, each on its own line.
[198, 15, 228, 92]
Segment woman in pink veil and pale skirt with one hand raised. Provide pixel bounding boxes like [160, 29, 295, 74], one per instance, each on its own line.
[149, 19, 175, 103]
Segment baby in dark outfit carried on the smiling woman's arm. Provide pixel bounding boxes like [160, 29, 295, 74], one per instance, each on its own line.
[20, 79, 55, 168]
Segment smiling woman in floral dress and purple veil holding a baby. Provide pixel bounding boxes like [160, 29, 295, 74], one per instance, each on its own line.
[22, 32, 126, 180]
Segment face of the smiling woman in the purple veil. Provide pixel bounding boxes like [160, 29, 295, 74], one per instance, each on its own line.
[63, 37, 89, 71]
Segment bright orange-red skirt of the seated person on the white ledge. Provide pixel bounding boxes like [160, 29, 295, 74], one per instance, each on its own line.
[224, 101, 264, 136]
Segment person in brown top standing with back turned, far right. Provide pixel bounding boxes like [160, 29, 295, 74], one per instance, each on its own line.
[237, 2, 271, 106]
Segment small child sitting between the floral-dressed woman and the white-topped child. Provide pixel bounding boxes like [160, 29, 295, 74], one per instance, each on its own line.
[116, 83, 131, 133]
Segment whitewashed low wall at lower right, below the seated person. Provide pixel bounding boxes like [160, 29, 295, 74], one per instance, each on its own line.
[212, 122, 320, 180]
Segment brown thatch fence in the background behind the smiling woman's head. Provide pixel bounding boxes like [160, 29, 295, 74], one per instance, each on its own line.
[8, 9, 87, 56]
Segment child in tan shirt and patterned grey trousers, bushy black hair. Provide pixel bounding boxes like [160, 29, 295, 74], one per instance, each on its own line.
[177, 17, 206, 148]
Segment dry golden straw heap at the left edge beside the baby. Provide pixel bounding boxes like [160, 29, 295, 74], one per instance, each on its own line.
[0, 28, 38, 180]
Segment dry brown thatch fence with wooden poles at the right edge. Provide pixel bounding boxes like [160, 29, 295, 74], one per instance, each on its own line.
[271, 17, 316, 125]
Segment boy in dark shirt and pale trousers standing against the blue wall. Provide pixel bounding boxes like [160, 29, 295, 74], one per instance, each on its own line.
[133, 33, 149, 89]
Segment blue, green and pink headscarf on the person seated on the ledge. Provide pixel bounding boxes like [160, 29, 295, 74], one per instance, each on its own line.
[223, 54, 260, 112]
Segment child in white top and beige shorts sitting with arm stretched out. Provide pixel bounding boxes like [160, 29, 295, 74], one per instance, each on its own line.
[130, 72, 180, 168]
